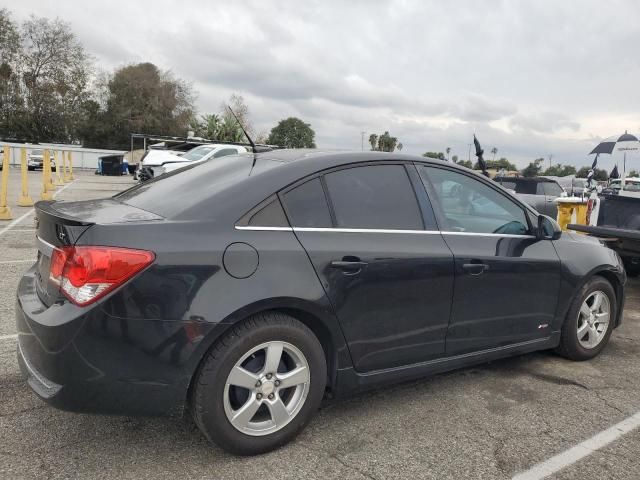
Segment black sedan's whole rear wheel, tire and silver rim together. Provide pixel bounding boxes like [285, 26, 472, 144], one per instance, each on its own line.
[192, 313, 327, 455]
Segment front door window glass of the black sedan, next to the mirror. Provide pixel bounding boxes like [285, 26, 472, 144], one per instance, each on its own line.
[419, 166, 529, 235]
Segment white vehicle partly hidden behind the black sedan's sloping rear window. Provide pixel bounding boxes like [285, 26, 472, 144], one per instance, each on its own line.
[142, 143, 248, 178]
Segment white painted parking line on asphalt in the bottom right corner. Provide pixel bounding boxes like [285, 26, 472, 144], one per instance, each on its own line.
[512, 412, 640, 480]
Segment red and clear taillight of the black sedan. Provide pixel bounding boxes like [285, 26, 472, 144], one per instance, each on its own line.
[49, 247, 155, 306]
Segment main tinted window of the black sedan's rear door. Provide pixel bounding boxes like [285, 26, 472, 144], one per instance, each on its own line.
[324, 165, 424, 230]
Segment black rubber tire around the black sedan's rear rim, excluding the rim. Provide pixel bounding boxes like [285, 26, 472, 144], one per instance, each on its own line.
[191, 312, 327, 455]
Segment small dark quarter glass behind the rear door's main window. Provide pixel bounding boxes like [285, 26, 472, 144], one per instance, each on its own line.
[283, 178, 331, 228]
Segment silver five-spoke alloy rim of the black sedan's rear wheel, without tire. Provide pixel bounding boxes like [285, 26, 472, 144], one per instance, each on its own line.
[223, 341, 310, 436]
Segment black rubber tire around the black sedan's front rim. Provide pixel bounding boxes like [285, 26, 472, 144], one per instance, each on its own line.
[555, 275, 618, 361]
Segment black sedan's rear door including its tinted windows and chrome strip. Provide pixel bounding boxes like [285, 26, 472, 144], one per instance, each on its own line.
[281, 163, 453, 372]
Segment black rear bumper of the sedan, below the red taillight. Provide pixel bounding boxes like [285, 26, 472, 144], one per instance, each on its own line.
[16, 269, 208, 416]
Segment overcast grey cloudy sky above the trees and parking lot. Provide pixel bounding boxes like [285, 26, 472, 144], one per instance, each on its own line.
[8, 0, 640, 167]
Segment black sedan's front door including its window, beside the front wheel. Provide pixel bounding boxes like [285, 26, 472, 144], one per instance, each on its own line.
[419, 166, 560, 355]
